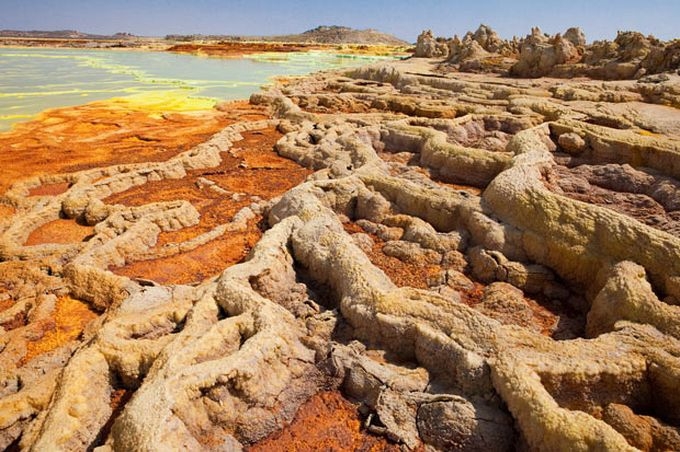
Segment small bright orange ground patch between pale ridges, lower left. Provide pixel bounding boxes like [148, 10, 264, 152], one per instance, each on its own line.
[20, 296, 97, 365]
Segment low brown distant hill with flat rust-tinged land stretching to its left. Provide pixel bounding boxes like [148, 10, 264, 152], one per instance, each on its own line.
[165, 25, 408, 46]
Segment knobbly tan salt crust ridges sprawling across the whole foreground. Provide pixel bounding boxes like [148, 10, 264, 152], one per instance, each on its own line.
[0, 52, 680, 451]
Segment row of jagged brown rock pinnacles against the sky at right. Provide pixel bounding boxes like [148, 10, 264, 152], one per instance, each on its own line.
[414, 24, 680, 83]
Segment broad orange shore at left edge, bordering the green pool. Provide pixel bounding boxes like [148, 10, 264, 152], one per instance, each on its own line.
[0, 101, 264, 195]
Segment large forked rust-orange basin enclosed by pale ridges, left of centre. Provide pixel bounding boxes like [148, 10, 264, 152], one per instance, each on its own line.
[110, 128, 310, 284]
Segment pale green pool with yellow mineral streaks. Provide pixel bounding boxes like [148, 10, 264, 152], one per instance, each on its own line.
[0, 48, 390, 131]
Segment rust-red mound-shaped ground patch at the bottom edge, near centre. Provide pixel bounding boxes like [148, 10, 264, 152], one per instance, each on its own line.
[248, 392, 401, 452]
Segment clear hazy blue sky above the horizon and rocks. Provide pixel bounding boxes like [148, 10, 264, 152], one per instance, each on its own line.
[0, 0, 680, 41]
